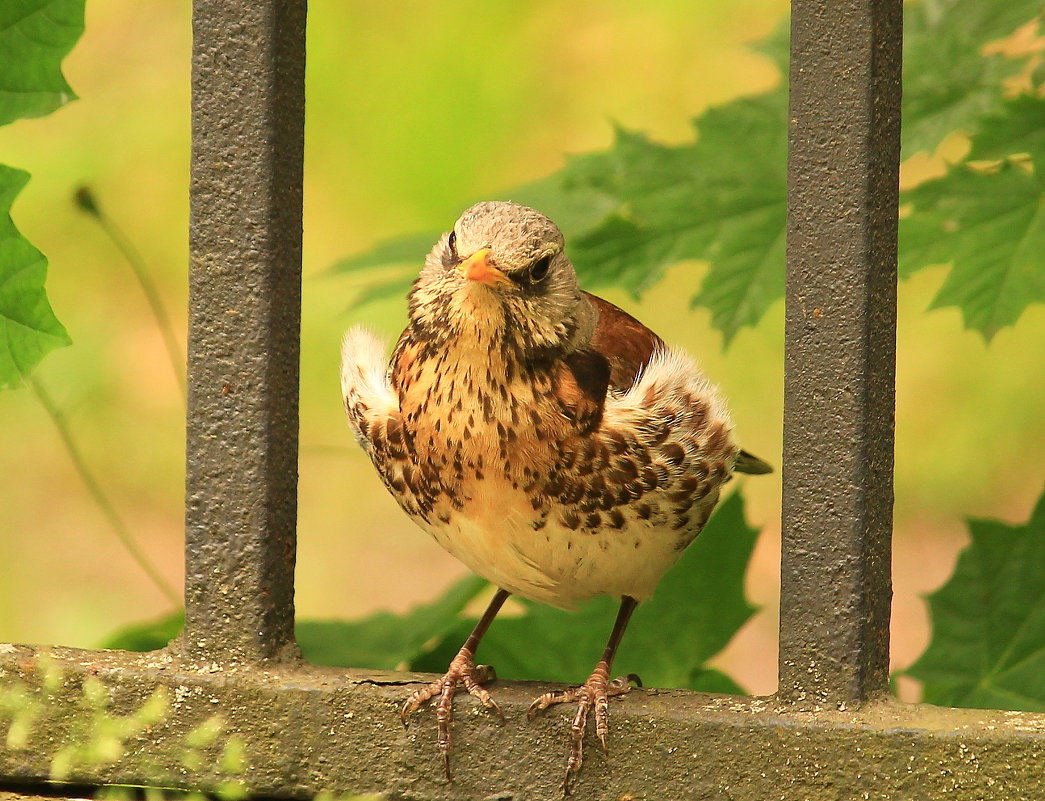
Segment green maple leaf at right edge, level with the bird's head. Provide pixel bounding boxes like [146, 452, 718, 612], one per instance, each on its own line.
[900, 164, 1045, 339]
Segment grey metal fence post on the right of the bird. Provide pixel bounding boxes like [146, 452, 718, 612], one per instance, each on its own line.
[780, 0, 902, 704]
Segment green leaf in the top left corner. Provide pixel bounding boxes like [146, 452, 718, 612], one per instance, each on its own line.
[0, 0, 84, 125]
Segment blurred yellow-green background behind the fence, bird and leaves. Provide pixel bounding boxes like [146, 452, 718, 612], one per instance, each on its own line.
[0, 0, 1045, 696]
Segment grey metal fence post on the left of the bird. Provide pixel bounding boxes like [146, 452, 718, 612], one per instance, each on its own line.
[182, 0, 305, 662]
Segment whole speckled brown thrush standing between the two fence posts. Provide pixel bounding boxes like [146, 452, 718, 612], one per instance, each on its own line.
[341, 202, 771, 795]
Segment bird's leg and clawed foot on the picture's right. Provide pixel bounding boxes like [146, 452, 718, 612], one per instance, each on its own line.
[528, 595, 642, 796]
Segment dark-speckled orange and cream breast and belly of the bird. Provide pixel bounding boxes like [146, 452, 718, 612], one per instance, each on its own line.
[375, 338, 736, 607]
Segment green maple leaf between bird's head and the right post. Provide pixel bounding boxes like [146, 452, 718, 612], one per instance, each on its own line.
[567, 96, 787, 343]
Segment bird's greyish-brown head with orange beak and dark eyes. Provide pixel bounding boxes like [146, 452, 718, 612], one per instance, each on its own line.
[410, 202, 589, 357]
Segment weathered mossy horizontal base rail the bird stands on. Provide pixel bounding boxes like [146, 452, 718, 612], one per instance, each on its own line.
[0, 645, 1045, 801]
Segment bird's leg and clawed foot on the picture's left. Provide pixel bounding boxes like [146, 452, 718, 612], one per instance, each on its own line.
[399, 589, 511, 779]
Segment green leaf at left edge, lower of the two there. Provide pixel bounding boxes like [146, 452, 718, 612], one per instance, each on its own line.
[0, 165, 69, 388]
